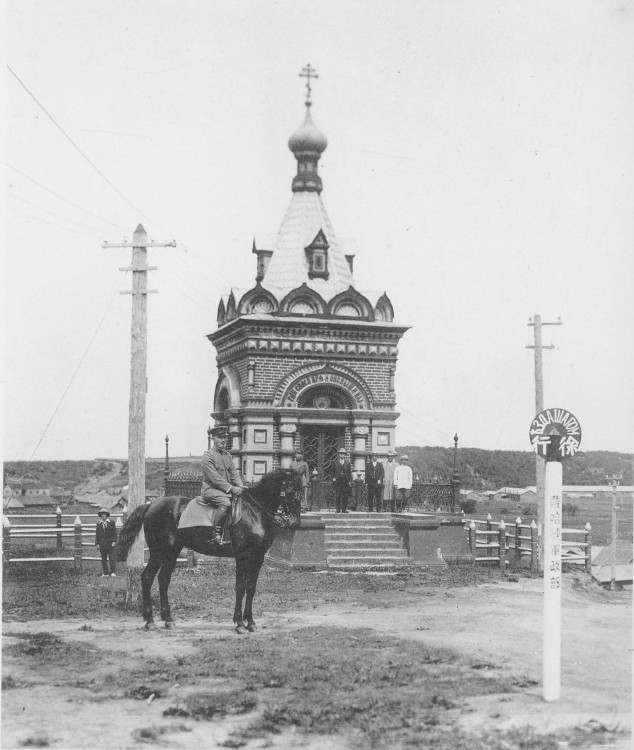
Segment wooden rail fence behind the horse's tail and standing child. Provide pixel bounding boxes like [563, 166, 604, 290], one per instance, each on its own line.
[2, 508, 215, 570]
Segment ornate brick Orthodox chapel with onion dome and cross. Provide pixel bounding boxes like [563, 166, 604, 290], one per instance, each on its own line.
[208, 73, 408, 481]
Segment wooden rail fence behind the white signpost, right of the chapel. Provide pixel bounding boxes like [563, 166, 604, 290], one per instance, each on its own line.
[465, 513, 592, 571]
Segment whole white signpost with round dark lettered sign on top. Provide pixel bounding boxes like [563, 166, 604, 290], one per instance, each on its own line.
[529, 409, 581, 701]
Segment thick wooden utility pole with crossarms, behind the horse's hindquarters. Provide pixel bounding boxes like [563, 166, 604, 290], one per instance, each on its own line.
[103, 224, 176, 605]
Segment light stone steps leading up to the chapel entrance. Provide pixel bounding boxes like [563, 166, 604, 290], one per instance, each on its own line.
[323, 511, 414, 572]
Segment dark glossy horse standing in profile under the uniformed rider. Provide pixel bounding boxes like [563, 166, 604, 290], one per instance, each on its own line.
[117, 469, 302, 633]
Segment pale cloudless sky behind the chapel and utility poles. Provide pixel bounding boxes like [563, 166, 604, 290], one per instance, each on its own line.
[2, 0, 634, 461]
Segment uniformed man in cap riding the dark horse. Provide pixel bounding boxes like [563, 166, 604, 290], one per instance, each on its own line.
[202, 426, 243, 544]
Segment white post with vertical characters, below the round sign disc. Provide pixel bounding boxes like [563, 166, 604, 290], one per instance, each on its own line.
[542, 461, 562, 701]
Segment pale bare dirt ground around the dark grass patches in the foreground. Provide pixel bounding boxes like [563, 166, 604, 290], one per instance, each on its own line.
[2, 574, 632, 750]
